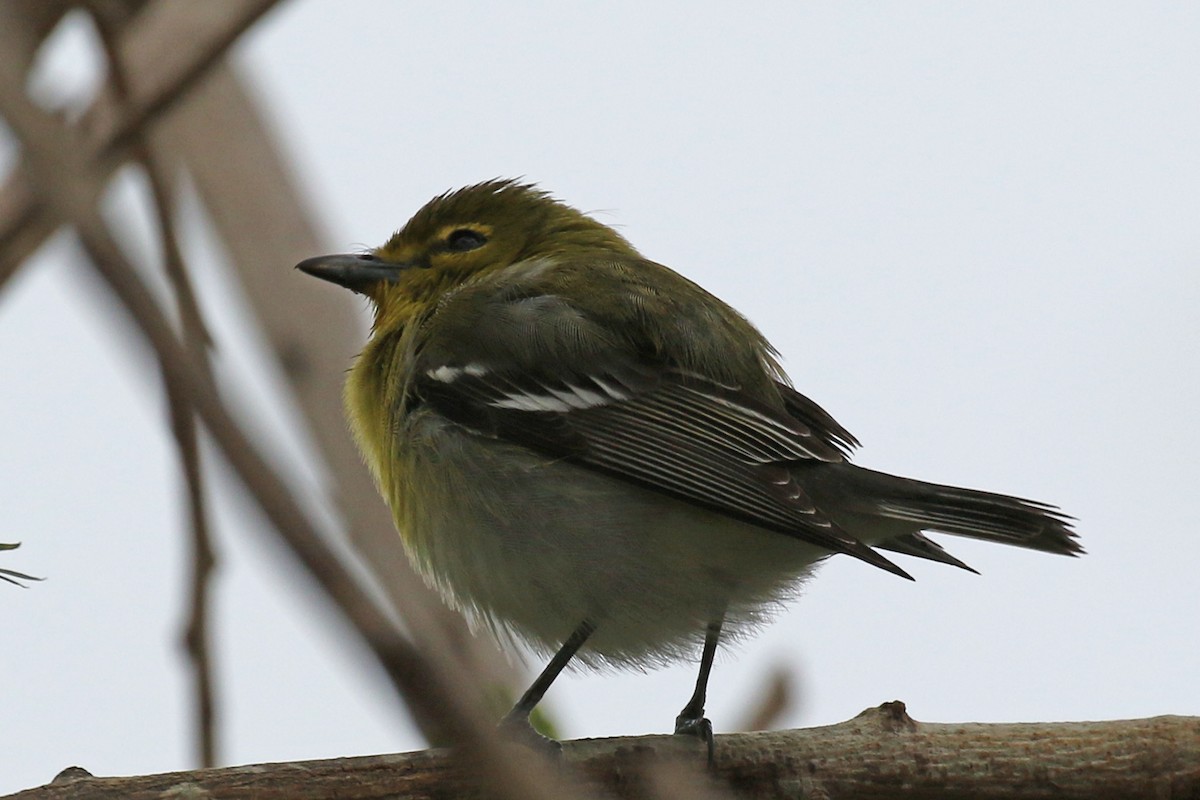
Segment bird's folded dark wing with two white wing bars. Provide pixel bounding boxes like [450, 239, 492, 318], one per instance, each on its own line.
[412, 281, 907, 577]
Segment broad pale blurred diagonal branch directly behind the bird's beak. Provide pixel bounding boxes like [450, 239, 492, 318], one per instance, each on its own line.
[156, 65, 524, 716]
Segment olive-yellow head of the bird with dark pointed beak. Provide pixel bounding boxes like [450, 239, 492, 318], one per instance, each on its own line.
[298, 180, 637, 315]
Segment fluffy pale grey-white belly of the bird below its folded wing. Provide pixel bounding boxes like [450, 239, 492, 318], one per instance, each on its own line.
[395, 411, 828, 666]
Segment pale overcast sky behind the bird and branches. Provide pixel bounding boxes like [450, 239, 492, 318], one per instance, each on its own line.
[0, 0, 1200, 793]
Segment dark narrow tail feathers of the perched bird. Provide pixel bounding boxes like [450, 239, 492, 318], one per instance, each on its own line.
[803, 464, 1084, 569]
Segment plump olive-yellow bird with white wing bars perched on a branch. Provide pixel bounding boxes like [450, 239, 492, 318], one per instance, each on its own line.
[298, 179, 1082, 760]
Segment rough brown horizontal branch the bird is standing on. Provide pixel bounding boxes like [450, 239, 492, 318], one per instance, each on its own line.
[5, 703, 1200, 800]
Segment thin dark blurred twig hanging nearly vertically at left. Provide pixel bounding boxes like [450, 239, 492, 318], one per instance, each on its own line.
[91, 0, 217, 766]
